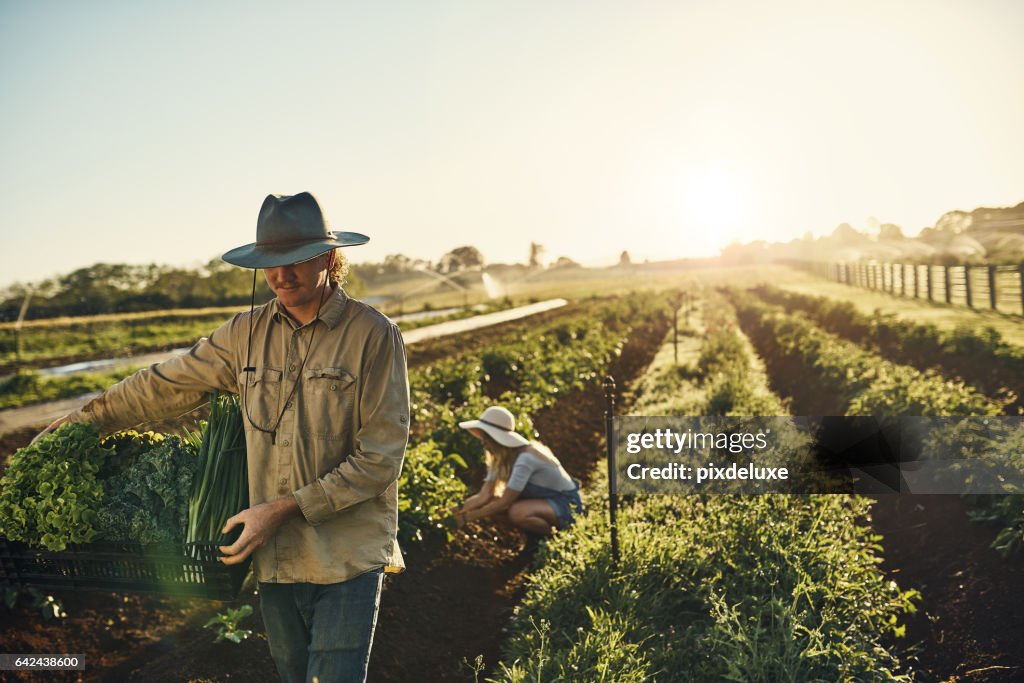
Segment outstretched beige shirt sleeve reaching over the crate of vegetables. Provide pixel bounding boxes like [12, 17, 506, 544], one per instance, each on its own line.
[70, 316, 239, 432]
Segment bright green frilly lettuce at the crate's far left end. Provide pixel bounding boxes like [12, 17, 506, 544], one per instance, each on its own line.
[0, 423, 111, 550]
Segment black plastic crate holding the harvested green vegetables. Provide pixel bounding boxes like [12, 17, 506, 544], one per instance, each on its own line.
[0, 539, 250, 600]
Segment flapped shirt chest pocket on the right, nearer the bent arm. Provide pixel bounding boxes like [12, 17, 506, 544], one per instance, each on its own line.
[299, 368, 355, 440]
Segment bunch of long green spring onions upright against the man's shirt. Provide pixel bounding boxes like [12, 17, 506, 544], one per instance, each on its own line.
[187, 392, 249, 545]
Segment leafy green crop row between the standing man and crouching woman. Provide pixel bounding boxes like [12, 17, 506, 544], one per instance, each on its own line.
[398, 296, 665, 541]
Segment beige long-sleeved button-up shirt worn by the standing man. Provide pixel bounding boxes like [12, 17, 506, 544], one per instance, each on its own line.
[72, 288, 409, 584]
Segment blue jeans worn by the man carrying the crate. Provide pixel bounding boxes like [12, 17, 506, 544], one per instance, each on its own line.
[259, 569, 384, 683]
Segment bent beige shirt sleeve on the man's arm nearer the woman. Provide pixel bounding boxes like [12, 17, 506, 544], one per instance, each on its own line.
[294, 324, 409, 526]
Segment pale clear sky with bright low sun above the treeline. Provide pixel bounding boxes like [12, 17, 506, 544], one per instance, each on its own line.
[0, 0, 1024, 287]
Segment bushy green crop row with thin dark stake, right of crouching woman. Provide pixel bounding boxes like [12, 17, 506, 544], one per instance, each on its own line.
[489, 300, 918, 682]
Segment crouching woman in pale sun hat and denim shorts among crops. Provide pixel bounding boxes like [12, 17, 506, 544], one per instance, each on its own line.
[453, 405, 584, 537]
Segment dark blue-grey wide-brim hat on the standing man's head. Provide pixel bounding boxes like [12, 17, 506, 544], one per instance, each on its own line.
[221, 193, 370, 268]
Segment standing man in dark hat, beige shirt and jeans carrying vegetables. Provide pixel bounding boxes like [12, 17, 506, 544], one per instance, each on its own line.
[36, 193, 409, 683]
